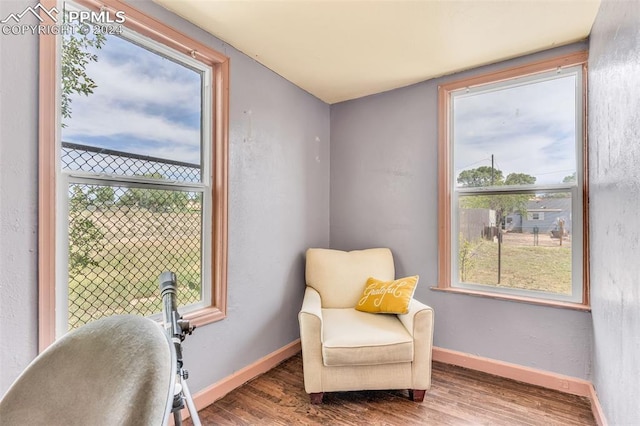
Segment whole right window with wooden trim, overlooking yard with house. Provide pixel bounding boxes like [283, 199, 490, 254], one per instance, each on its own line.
[438, 52, 588, 309]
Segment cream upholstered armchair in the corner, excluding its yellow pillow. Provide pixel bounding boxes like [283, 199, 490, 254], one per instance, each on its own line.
[298, 248, 433, 404]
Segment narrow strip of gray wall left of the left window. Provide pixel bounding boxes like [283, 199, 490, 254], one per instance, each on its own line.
[0, 0, 38, 395]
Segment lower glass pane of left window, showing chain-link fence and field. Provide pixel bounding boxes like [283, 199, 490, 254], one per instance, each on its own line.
[68, 184, 202, 328]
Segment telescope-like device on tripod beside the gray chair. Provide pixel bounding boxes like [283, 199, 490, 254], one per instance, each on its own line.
[160, 271, 201, 426]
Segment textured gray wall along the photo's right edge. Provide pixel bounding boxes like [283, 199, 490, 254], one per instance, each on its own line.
[589, 0, 640, 425]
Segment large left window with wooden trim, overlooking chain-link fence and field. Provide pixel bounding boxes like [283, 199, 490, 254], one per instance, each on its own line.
[40, 1, 228, 348]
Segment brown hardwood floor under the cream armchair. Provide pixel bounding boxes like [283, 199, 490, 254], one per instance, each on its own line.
[185, 354, 596, 426]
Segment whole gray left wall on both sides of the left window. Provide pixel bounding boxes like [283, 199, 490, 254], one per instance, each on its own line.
[0, 0, 329, 395]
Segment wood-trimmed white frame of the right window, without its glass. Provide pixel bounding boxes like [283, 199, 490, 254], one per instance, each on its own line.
[435, 52, 589, 309]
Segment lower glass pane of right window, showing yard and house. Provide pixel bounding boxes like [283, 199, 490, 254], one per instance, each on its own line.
[457, 193, 572, 295]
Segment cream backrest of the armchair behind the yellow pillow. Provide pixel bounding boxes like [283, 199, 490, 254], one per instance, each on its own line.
[305, 248, 395, 308]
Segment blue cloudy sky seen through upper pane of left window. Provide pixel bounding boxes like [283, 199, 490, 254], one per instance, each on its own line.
[62, 32, 201, 164]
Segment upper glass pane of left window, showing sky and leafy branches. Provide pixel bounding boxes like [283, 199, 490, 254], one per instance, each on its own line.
[62, 33, 203, 182]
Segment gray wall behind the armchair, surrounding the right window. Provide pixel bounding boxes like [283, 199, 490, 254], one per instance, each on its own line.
[331, 43, 592, 379]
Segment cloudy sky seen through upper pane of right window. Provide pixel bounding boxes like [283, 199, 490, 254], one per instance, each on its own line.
[454, 76, 576, 184]
